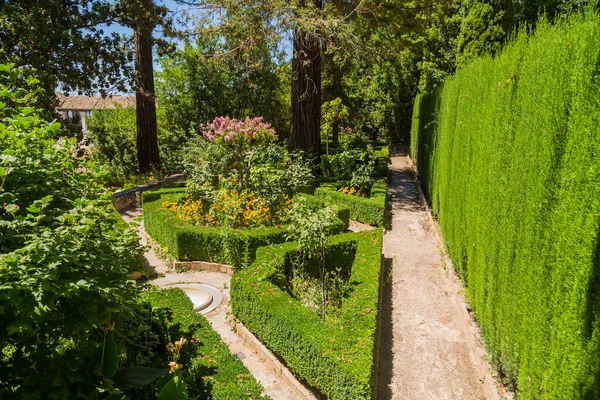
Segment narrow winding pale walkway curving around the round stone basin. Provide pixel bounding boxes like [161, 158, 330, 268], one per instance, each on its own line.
[120, 208, 316, 400]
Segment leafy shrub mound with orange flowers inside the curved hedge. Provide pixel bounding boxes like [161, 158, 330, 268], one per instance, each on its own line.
[182, 133, 313, 228]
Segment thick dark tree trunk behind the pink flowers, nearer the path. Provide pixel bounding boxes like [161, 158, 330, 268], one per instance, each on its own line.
[289, 0, 321, 162]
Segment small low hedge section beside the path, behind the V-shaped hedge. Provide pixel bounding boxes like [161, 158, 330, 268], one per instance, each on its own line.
[315, 178, 387, 227]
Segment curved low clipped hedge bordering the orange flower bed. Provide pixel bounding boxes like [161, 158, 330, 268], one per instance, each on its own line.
[142, 188, 350, 268]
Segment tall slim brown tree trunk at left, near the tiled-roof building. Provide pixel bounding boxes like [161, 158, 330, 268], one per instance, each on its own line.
[134, 5, 160, 174]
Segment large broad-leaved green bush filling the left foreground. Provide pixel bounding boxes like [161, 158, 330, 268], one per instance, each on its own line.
[0, 66, 141, 399]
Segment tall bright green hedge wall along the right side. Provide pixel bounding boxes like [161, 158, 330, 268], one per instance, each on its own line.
[411, 15, 600, 400]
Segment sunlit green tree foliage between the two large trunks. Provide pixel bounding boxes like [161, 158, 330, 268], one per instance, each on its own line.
[156, 28, 291, 135]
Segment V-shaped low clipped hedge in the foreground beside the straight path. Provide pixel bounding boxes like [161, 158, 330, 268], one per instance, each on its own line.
[231, 229, 382, 400]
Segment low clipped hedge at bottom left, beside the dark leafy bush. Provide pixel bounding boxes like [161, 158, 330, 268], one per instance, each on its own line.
[143, 289, 265, 400]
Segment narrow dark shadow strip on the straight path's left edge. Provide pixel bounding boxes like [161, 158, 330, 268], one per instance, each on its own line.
[375, 258, 394, 400]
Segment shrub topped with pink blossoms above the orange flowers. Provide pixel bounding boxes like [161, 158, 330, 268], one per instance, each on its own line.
[202, 117, 277, 191]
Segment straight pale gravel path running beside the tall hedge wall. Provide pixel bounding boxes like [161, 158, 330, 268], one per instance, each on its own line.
[377, 148, 504, 400]
